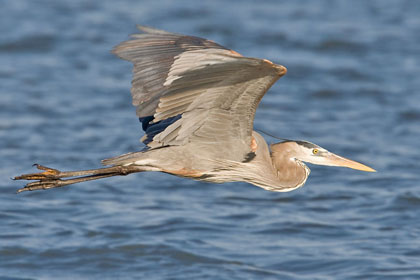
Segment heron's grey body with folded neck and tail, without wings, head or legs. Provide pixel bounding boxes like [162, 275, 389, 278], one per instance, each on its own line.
[103, 131, 310, 191]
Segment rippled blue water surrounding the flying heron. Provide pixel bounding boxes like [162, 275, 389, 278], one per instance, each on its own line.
[0, 0, 420, 279]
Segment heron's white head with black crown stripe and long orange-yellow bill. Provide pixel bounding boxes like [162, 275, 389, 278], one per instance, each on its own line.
[272, 140, 376, 172]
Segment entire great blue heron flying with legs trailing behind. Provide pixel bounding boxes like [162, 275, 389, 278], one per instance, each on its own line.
[14, 26, 375, 192]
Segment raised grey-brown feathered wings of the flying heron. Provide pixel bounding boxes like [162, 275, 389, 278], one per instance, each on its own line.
[113, 26, 286, 161]
